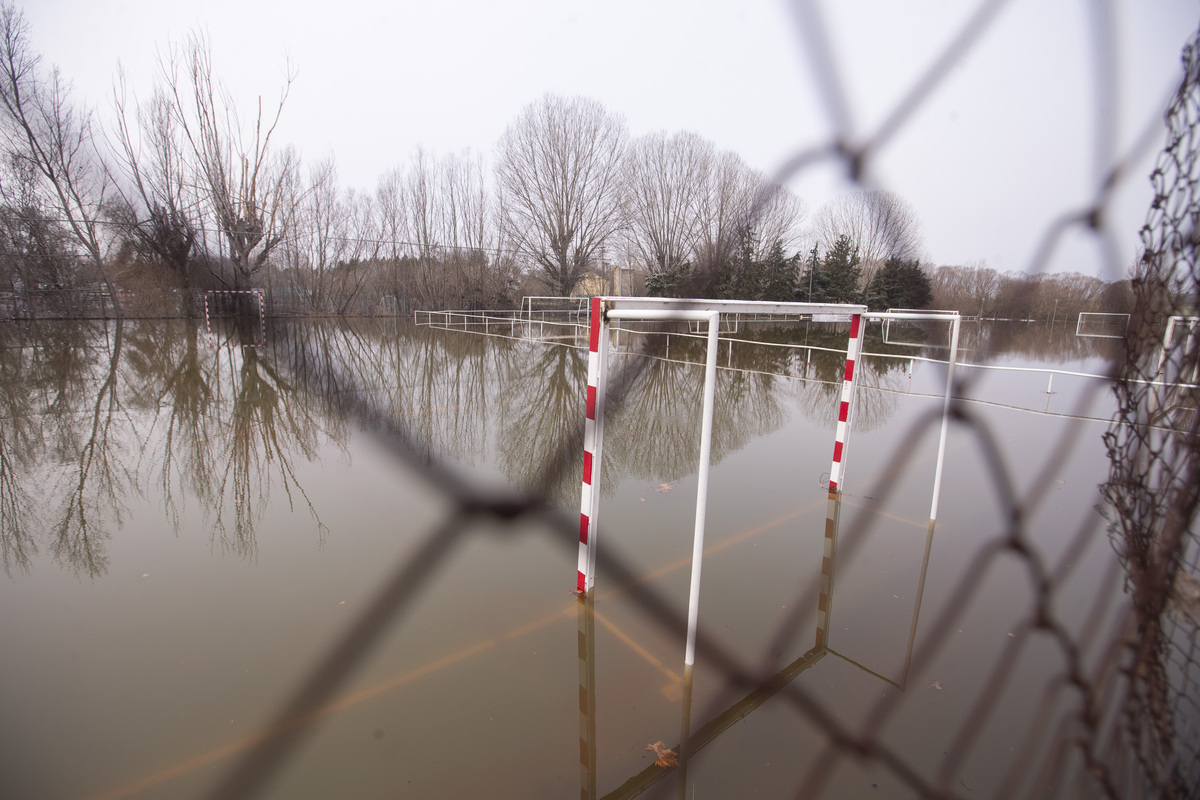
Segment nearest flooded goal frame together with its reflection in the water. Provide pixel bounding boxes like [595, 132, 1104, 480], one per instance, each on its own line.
[576, 297, 960, 798]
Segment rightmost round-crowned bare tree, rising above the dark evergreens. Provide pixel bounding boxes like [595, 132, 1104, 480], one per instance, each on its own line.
[812, 192, 923, 287]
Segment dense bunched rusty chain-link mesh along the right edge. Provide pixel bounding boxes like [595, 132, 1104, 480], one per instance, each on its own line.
[1104, 21, 1200, 798]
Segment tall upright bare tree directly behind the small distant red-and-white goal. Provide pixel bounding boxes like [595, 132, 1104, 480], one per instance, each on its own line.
[161, 34, 298, 287]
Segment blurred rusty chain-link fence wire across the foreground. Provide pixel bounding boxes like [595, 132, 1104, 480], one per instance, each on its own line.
[189, 0, 1200, 799]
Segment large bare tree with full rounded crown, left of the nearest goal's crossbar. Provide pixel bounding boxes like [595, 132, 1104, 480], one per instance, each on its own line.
[496, 95, 628, 295]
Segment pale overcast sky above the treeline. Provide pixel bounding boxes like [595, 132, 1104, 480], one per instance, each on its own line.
[18, 0, 1200, 278]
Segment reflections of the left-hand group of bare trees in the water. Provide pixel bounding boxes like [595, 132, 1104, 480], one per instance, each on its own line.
[0, 320, 345, 576]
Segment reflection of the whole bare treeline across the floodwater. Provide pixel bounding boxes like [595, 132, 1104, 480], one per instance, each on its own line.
[0, 320, 926, 575]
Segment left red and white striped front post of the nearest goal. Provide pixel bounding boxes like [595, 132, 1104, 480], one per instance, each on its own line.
[575, 297, 608, 593]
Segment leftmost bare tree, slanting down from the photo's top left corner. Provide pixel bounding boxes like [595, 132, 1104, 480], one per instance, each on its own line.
[0, 2, 121, 317]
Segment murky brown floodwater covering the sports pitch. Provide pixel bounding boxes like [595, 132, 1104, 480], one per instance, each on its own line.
[0, 320, 1121, 800]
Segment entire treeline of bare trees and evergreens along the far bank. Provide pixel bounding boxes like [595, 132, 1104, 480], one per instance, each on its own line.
[0, 1, 1128, 318]
